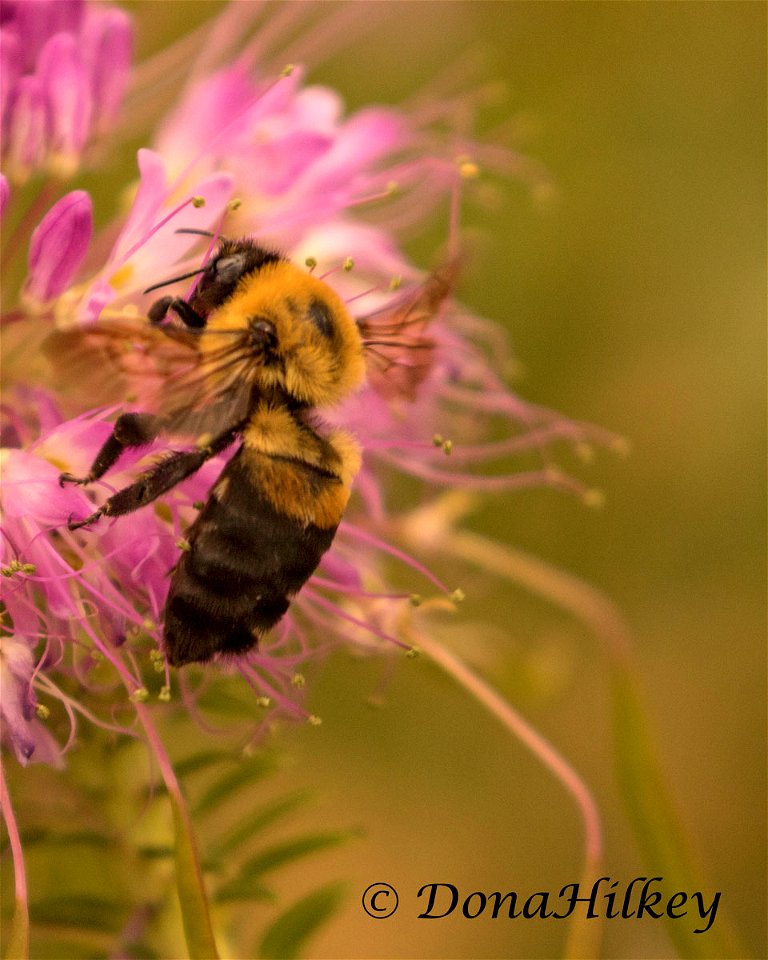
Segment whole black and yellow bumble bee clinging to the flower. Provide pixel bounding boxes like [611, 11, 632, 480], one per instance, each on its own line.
[60, 239, 449, 667]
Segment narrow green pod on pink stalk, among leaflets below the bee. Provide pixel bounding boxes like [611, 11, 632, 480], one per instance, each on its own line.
[168, 793, 219, 960]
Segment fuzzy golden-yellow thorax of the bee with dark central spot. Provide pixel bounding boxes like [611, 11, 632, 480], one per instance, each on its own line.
[200, 261, 365, 406]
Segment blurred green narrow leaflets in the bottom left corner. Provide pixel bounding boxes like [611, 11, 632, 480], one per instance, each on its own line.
[2, 681, 356, 960]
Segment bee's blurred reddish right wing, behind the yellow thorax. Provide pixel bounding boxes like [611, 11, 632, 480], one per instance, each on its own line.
[357, 261, 458, 400]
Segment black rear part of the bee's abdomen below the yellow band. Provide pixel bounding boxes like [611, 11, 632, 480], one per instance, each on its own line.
[165, 448, 340, 666]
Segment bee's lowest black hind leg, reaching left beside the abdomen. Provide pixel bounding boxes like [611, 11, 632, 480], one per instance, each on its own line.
[67, 424, 240, 530]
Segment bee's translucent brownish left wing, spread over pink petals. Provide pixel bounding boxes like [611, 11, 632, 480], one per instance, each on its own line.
[44, 317, 254, 438]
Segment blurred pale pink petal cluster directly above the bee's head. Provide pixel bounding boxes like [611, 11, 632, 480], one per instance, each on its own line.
[151, 64, 411, 249]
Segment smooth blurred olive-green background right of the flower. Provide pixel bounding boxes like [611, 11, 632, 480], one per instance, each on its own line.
[13, 2, 768, 958]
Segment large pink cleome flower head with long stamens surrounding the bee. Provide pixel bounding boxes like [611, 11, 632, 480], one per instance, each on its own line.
[0, 3, 612, 763]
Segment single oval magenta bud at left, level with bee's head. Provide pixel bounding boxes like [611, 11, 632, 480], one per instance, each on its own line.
[24, 190, 93, 303]
